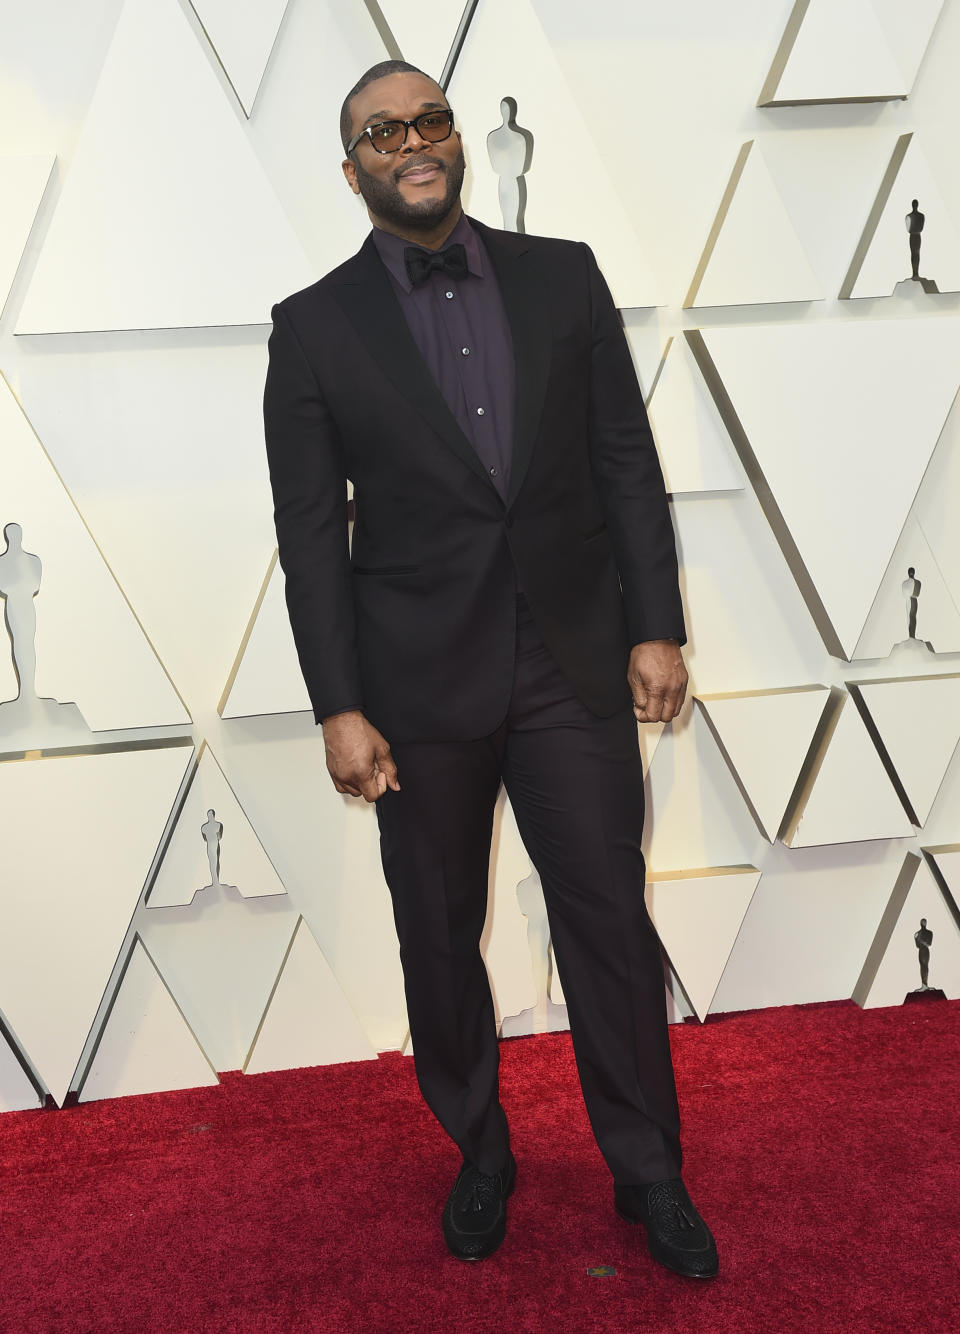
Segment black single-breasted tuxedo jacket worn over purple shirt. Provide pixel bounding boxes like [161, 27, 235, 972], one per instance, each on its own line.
[264, 214, 684, 742]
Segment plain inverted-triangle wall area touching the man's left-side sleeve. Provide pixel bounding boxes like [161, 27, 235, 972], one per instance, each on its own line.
[20, 338, 276, 718]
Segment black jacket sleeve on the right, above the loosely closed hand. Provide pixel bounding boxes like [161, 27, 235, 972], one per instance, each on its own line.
[584, 247, 687, 644]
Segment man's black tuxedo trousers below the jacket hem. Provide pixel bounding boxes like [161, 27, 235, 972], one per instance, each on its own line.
[377, 596, 680, 1185]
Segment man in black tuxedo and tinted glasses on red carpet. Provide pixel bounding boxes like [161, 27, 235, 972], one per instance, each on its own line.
[264, 61, 716, 1277]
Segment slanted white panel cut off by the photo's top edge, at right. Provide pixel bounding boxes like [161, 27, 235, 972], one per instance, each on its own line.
[759, 0, 943, 107]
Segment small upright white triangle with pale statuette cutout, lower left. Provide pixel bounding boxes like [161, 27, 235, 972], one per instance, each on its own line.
[147, 746, 287, 908]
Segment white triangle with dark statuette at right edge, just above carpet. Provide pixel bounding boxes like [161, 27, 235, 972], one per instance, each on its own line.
[853, 855, 960, 1010]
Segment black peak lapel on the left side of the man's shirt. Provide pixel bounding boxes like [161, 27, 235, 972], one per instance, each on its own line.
[336, 237, 496, 494]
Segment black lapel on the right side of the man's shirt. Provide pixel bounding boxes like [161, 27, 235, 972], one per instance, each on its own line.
[471, 219, 552, 506]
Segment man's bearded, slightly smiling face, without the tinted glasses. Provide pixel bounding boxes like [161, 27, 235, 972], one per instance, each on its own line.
[343, 73, 464, 232]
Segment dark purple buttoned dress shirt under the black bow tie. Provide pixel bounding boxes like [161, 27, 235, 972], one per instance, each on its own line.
[373, 215, 516, 500]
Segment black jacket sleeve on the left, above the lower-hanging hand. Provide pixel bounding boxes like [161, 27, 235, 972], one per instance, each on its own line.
[264, 305, 363, 722]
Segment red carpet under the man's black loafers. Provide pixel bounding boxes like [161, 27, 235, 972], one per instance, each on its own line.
[0, 1002, 960, 1334]
